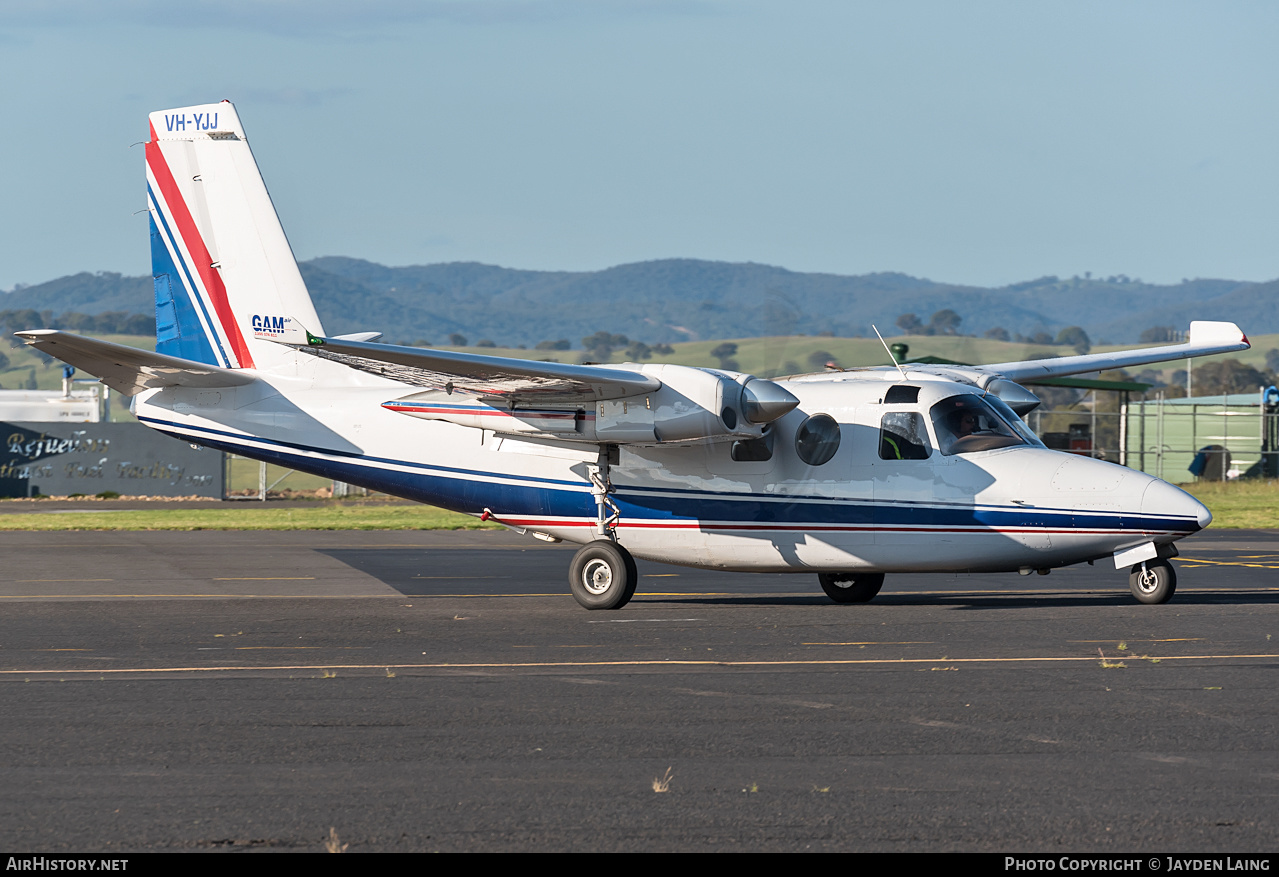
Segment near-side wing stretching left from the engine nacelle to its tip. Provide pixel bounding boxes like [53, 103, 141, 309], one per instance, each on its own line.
[280, 332, 661, 403]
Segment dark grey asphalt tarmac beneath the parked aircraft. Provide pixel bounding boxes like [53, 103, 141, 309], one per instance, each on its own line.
[0, 521, 1279, 854]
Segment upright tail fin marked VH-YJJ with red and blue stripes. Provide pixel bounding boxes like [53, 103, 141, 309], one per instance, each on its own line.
[147, 101, 324, 369]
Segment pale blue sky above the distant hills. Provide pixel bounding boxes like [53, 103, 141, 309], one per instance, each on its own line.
[0, 0, 1279, 289]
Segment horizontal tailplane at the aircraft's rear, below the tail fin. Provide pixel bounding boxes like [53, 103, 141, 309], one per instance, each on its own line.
[17, 329, 255, 396]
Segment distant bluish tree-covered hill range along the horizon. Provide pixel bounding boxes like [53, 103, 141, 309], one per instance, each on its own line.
[0, 257, 1279, 347]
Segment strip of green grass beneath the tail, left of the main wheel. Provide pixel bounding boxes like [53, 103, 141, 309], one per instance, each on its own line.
[0, 501, 498, 531]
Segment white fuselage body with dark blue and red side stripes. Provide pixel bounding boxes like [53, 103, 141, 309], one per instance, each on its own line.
[134, 358, 1210, 573]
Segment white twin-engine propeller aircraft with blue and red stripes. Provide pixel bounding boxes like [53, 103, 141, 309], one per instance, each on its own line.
[18, 102, 1248, 609]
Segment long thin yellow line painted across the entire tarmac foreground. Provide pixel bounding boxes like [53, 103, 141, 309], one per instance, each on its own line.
[7, 653, 1279, 676]
